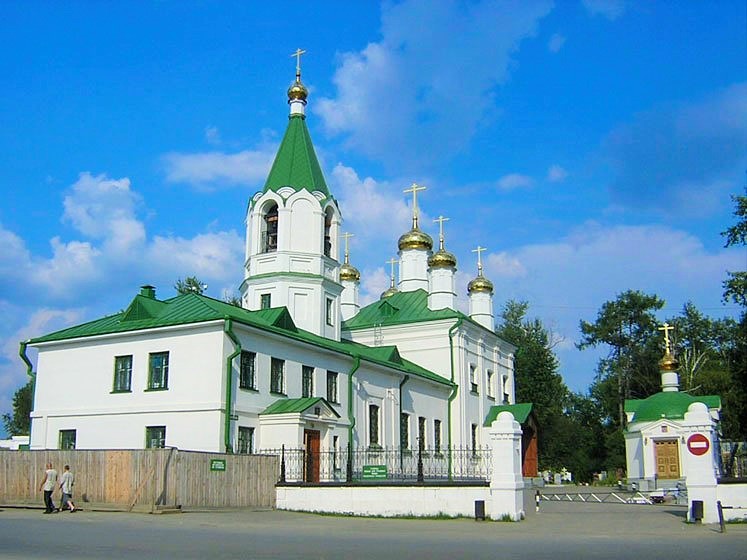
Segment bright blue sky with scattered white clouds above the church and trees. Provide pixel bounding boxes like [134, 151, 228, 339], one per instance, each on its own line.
[0, 0, 747, 434]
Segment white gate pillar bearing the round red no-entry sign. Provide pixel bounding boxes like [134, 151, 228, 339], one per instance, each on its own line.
[682, 402, 718, 523]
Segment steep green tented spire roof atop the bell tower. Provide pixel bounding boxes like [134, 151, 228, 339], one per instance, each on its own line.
[263, 115, 329, 198]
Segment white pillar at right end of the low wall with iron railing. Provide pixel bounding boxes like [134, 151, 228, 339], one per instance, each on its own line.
[488, 411, 525, 521]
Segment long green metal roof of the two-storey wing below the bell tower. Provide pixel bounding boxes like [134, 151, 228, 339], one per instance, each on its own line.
[30, 286, 452, 385]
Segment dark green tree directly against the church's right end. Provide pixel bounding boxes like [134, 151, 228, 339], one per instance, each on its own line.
[496, 300, 568, 467]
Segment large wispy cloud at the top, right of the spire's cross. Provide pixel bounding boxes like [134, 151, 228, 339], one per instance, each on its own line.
[310, 0, 551, 169]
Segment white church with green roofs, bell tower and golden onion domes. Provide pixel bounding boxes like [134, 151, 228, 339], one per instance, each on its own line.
[21, 55, 536, 479]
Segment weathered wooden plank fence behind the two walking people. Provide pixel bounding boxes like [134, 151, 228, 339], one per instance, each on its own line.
[0, 448, 280, 511]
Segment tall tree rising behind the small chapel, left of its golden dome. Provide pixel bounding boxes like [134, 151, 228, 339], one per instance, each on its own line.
[576, 290, 664, 428]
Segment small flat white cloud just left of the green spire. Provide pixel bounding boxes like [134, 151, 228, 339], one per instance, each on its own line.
[163, 146, 277, 188]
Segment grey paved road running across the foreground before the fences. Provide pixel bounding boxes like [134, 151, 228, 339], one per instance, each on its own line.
[0, 502, 747, 560]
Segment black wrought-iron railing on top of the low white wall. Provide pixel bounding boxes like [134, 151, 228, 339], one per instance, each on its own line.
[260, 446, 492, 483]
